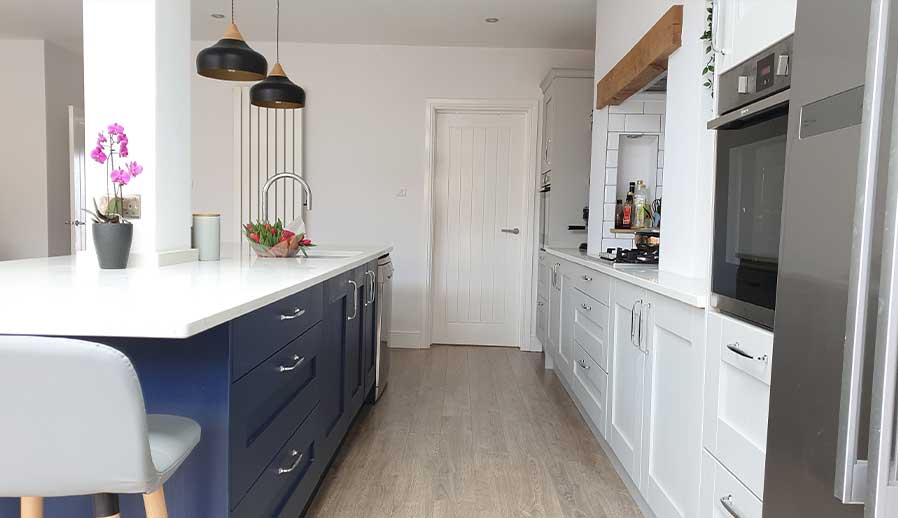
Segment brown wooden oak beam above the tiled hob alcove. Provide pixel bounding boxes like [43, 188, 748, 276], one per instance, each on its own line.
[596, 5, 683, 110]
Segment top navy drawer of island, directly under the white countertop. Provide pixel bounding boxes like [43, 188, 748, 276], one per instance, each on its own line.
[231, 284, 324, 380]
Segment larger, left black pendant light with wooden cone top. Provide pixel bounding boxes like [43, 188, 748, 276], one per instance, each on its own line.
[196, 0, 268, 81]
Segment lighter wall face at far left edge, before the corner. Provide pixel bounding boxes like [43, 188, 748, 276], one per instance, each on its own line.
[0, 40, 47, 260]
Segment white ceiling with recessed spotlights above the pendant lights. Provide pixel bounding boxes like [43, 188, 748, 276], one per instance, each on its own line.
[0, 0, 596, 49]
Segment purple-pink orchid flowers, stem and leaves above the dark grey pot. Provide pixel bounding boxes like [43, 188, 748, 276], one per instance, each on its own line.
[85, 123, 143, 223]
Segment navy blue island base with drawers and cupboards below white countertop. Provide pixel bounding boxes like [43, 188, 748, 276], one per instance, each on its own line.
[0, 258, 379, 518]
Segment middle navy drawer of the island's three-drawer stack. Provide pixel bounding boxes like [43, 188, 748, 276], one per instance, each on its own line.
[230, 324, 324, 508]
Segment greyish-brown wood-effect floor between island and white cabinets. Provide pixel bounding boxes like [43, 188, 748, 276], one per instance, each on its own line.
[307, 346, 642, 518]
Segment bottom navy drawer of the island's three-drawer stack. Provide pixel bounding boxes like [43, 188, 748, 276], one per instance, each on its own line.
[231, 407, 324, 518]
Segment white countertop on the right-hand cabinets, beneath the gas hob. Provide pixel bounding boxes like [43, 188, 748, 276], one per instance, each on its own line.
[545, 248, 708, 308]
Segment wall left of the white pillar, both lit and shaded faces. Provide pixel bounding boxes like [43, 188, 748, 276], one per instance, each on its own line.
[0, 40, 84, 260]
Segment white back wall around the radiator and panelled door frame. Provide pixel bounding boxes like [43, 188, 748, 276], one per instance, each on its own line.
[193, 41, 593, 346]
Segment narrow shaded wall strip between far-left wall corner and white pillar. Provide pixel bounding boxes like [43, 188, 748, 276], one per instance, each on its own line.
[44, 42, 84, 256]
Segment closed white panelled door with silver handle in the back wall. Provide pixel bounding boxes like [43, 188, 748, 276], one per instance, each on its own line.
[431, 113, 529, 346]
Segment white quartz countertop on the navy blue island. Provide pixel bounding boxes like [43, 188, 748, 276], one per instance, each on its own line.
[0, 246, 392, 338]
